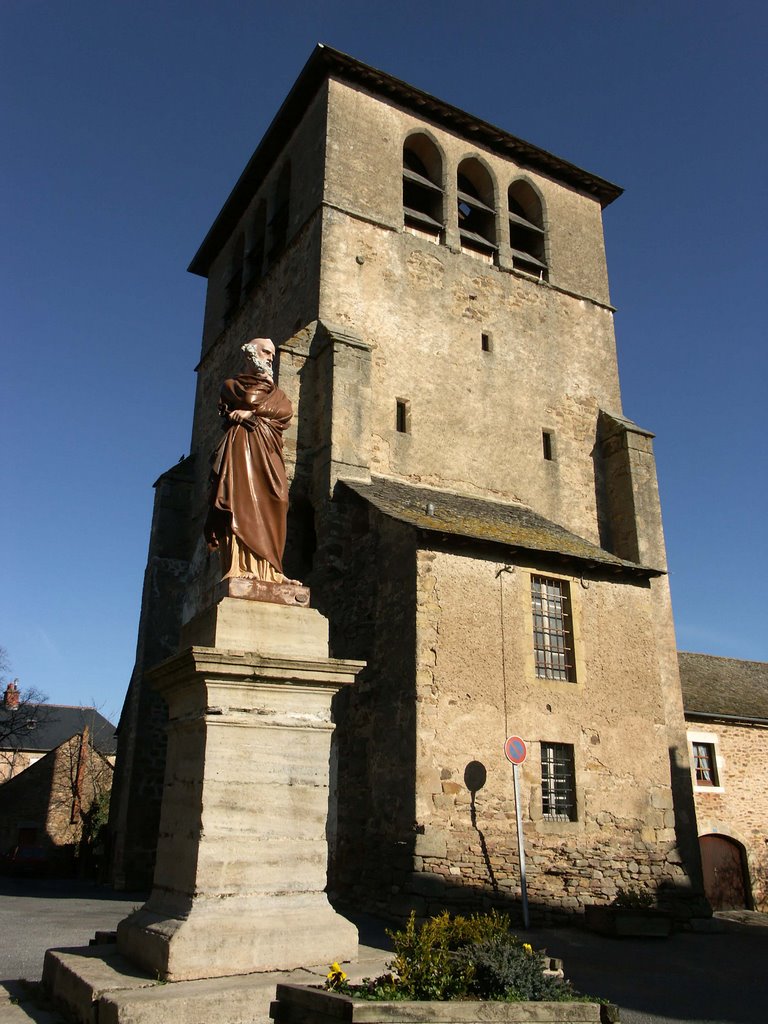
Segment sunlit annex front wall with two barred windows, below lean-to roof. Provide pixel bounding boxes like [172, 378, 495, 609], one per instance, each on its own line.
[411, 550, 697, 919]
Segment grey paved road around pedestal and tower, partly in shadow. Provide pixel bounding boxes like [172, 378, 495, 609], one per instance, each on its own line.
[0, 879, 768, 1024]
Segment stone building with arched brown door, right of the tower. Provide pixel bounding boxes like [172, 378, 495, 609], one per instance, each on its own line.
[678, 651, 768, 910]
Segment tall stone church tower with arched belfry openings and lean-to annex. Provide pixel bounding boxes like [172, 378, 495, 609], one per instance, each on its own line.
[113, 46, 700, 920]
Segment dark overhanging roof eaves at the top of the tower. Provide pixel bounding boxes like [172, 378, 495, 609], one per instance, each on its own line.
[189, 43, 624, 276]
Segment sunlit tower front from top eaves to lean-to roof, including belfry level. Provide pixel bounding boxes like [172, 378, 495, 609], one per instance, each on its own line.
[319, 82, 621, 543]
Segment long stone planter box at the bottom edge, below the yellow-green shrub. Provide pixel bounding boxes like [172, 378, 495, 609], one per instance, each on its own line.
[269, 985, 618, 1024]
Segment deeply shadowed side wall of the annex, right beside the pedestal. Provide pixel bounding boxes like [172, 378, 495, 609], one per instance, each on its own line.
[325, 512, 416, 912]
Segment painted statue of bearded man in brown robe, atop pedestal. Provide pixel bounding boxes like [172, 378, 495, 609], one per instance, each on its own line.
[205, 338, 298, 583]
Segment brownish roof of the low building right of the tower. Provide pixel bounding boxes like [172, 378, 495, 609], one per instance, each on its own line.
[677, 650, 768, 722]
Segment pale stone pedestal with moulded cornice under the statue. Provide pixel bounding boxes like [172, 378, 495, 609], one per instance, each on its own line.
[118, 597, 362, 981]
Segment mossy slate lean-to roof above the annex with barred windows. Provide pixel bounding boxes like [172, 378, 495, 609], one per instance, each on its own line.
[344, 477, 663, 577]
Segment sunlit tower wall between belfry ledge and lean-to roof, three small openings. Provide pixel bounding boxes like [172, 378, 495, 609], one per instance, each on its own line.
[321, 211, 620, 543]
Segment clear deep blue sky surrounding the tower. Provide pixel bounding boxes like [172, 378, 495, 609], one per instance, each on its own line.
[0, 0, 768, 721]
